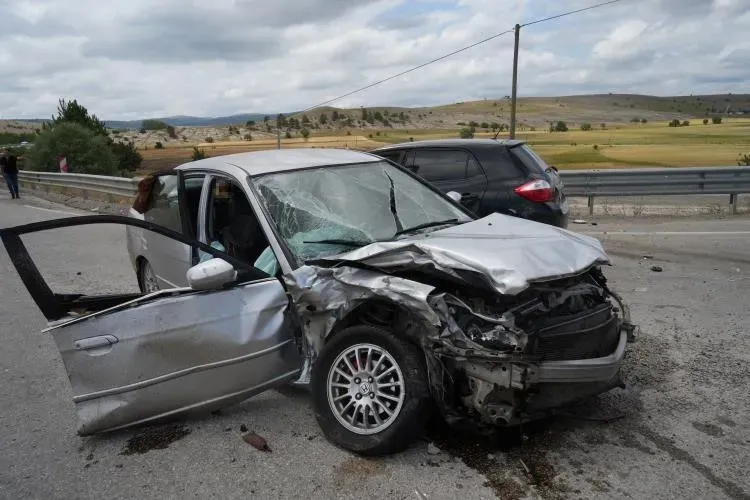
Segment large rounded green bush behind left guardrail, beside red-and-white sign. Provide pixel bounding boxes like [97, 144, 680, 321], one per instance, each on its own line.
[24, 122, 119, 175]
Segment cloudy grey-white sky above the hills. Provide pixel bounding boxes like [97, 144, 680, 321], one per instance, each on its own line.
[0, 0, 750, 119]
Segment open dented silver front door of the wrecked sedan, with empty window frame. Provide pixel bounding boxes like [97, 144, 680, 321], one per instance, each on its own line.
[0, 215, 302, 435]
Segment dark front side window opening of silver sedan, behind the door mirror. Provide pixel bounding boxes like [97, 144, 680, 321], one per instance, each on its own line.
[206, 178, 279, 276]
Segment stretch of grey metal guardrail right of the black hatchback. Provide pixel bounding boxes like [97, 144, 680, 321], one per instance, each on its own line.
[560, 167, 750, 214]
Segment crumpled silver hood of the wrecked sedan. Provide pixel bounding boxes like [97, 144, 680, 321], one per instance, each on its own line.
[315, 214, 609, 295]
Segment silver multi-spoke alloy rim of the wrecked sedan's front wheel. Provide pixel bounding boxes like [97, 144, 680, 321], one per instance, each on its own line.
[328, 344, 405, 434]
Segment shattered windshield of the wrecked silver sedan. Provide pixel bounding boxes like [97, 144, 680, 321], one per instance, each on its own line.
[253, 162, 471, 262]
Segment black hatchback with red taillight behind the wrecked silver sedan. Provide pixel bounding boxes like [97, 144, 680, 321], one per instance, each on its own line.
[371, 139, 568, 227]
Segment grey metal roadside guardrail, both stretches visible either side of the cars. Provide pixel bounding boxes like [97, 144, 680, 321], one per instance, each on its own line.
[18, 167, 750, 213]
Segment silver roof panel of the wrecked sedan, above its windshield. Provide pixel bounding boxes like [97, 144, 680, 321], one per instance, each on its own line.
[177, 148, 383, 176]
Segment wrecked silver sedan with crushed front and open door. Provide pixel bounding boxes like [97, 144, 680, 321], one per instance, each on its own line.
[0, 149, 635, 454]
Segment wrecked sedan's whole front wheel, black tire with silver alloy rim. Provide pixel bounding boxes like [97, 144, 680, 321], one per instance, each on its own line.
[311, 325, 432, 455]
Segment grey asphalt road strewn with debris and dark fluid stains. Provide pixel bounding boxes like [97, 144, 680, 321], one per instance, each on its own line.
[0, 195, 750, 500]
